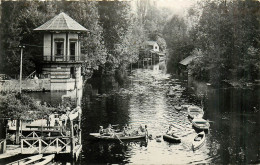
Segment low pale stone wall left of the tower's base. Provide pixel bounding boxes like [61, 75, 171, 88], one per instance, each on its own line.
[0, 79, 51, 92]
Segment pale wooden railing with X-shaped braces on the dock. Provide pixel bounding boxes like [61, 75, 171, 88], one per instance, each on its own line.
[21, 137, 71, 154]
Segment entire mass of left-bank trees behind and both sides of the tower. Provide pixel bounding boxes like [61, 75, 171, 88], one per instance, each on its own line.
[1, 1, 152, 75]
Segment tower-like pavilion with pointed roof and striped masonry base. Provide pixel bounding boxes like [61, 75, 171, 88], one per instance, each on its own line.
[34, 13, 88, 90]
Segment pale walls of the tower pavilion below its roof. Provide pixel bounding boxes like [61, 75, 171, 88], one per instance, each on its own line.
[42, 33, 82, 90]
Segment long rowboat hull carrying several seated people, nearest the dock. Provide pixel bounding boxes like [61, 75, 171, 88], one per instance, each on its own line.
[89, 133, 146, 140]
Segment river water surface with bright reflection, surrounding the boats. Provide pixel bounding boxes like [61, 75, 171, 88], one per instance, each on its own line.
[26, 69, 260, 164]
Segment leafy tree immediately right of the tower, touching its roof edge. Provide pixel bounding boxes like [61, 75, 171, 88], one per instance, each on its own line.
[64, 1, 107, 69]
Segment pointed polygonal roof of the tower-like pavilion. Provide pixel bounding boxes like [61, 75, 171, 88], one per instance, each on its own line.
[34, 12, 88, 32]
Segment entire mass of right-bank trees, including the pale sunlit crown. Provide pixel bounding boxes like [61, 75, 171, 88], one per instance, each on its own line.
[163, 0, 260, 84]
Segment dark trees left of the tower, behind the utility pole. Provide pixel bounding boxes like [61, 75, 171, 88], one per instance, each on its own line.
[1, 1, 58, 75]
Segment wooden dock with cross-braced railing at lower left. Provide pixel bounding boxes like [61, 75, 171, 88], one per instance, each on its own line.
[3, 107, 82, 160]
